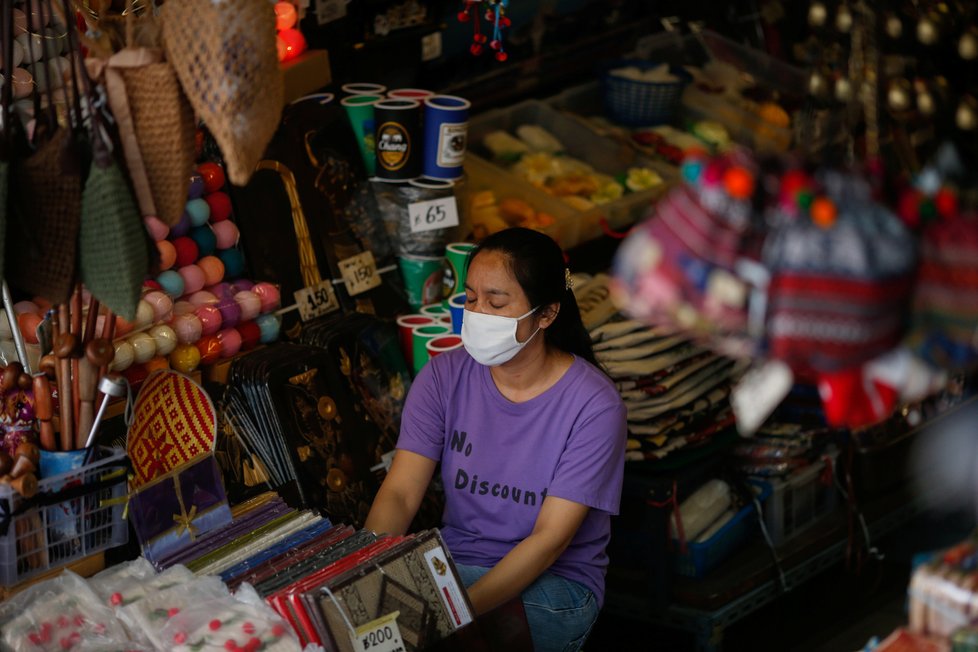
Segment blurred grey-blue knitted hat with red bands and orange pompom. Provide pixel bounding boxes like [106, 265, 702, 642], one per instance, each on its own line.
[763, 171, 915, 377]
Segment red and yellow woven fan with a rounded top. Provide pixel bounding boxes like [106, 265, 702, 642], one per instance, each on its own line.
[126, 371, 217, 489]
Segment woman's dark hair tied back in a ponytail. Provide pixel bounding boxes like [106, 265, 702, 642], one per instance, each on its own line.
[466, 227, 598, 366]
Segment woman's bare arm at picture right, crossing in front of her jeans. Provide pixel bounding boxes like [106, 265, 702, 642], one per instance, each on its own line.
[462, 496, 590, 614]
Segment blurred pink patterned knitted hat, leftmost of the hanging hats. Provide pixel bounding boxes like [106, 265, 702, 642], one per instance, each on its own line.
[614, 150, 760, 356]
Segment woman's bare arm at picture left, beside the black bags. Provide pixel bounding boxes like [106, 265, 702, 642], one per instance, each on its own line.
[364, 449, 437, 535]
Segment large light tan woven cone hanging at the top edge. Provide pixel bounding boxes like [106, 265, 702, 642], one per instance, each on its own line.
[162, 0, 284, 186]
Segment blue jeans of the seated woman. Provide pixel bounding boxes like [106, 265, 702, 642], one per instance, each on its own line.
[455, 564, 598, 652]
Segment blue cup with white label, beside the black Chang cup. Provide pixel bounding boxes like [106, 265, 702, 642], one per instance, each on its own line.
[423, 95, 472, 180]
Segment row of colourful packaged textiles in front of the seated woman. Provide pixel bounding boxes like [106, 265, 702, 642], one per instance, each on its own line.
[144, 492, 473, 652]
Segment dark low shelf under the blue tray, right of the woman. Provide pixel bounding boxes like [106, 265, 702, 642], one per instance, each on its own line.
[605, 490, 922, 652]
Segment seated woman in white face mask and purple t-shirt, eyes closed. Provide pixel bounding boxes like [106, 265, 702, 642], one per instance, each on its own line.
[366, 229, 626, 650]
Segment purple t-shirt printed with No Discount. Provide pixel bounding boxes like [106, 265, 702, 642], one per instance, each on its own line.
[397, 349, 626, 605]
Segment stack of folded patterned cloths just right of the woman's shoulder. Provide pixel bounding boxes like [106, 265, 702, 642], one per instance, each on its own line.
[574, 274, 742, 461]
